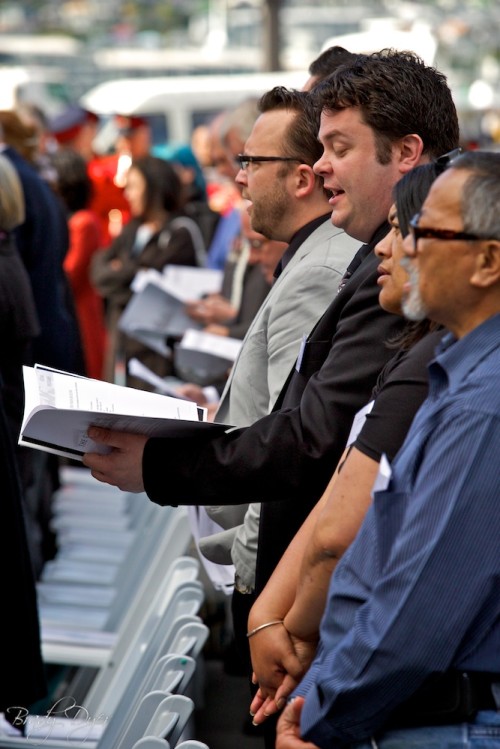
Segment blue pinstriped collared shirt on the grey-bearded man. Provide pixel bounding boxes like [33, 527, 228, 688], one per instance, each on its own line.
[297, 315, 500, 749]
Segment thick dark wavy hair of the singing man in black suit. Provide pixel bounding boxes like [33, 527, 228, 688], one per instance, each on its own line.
[311, 49, 459, 164]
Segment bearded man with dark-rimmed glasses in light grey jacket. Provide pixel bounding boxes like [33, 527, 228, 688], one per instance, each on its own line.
[200, 87, 357, 652]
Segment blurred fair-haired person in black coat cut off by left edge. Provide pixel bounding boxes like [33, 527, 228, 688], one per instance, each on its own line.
[0, 156, 46, 721]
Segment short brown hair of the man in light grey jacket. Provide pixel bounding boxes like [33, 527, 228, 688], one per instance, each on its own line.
[259, 86, 323, 167]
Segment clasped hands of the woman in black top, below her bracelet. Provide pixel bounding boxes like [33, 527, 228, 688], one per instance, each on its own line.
[249, 617, 318, 725]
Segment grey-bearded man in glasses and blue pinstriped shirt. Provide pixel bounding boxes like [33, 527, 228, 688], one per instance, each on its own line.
[276, 152, 500, 749]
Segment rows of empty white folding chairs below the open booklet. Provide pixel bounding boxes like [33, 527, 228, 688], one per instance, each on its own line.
[0, 468, 208, 749]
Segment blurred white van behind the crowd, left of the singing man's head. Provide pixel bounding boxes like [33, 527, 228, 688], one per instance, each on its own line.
[80, 71, 308, 144]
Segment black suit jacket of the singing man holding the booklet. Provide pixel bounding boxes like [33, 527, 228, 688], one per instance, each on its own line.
[143, 226, 404, 592]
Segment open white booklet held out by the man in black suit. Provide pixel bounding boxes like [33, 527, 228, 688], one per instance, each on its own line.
[19, 364, 230, 460]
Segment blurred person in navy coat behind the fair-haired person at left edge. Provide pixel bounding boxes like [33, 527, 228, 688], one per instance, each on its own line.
[0, 111, 85, 561]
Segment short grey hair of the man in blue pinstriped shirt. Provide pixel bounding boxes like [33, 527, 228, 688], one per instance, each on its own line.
[448, 151, 500, 239]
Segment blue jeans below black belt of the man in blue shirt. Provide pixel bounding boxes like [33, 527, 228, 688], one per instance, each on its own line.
[351, 710, 500, 749]
